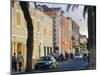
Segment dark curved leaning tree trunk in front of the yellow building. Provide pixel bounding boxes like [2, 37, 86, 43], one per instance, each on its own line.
[19, 1, 33, 72]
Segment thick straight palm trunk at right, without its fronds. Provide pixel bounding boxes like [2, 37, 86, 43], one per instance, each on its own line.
[88, 6, 96, 68]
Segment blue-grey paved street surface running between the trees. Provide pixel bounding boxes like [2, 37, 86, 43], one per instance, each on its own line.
[33, 59, 89, 73]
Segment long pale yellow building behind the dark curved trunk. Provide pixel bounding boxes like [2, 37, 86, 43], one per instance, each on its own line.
[11, 2, 53, 67]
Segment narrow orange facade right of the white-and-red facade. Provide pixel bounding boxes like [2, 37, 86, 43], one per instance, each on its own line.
[61, 15, 69, 56]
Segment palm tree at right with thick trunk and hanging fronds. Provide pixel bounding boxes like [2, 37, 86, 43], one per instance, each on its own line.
[67, 4, 96, 68]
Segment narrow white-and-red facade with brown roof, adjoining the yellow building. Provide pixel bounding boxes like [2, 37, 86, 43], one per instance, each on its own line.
[44, 8, 62, 54]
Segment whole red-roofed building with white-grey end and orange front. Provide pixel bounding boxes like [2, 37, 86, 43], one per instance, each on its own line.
[41, 5, 73, 56]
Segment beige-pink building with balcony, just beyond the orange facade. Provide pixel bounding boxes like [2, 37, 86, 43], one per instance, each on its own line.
[67, 17, 80, 55]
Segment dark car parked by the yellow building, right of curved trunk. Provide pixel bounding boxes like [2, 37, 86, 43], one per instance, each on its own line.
[35, 56, 57, 70]
